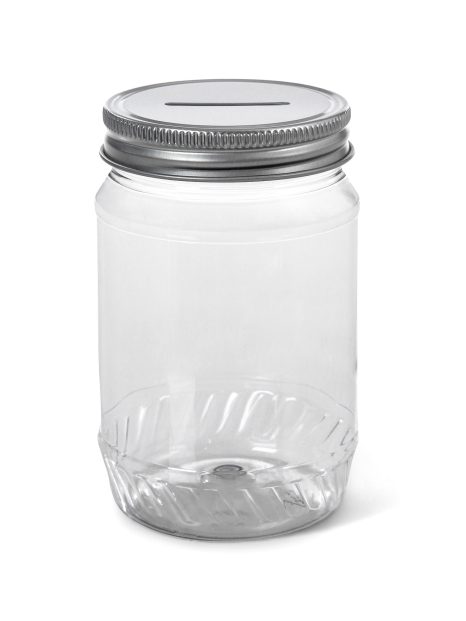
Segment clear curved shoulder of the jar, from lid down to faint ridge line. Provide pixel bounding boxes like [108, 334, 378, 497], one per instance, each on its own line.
[96, 169, 359, 243]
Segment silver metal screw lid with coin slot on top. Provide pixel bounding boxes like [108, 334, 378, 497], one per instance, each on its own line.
[101, 80, 353, 181]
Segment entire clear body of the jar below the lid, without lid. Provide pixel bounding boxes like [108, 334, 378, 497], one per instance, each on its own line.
[97, 170, 358, 539]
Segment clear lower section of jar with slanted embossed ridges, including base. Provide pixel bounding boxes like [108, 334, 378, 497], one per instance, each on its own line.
[99, 379, 356, 539]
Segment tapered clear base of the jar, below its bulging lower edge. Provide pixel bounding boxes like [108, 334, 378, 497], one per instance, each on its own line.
[102, 450, 351, 540]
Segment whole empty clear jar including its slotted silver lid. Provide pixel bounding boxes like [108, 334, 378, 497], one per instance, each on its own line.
[97, 80, 358, 539]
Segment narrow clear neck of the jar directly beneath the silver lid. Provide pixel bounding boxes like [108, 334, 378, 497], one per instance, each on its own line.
[109, 168, 346, 202]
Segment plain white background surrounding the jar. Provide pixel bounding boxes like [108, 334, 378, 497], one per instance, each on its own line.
[0, 0, 466, 621]
